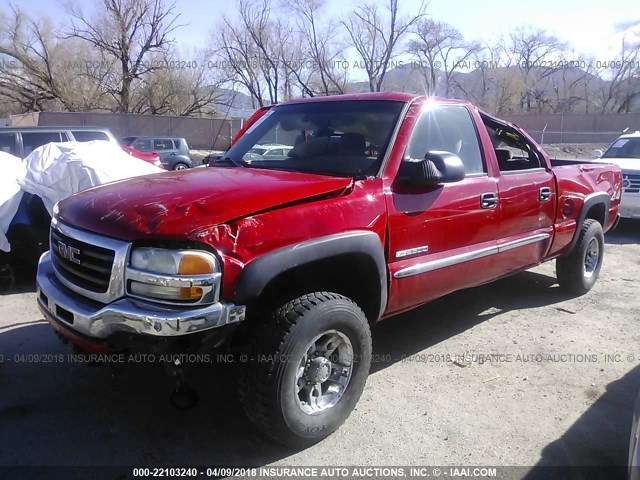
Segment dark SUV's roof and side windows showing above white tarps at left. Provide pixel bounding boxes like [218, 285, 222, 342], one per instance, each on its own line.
[0, 126, 118, 158]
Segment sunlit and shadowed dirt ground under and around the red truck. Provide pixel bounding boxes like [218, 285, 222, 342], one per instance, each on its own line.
[0, 222, 640, 477]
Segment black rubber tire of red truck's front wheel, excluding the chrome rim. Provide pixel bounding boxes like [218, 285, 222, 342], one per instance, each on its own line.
[238, 292, 371, 448]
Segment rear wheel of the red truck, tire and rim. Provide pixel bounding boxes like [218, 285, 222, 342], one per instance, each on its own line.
[556, 218, 604, 295]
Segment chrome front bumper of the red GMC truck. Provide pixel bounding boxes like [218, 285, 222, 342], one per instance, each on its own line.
[36, 252, 246, 341]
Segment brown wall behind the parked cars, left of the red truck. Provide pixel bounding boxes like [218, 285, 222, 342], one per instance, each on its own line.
[11, 112, 242, 150]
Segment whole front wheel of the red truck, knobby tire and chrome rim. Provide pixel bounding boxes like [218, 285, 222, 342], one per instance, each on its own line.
[238, 292, 371, 447]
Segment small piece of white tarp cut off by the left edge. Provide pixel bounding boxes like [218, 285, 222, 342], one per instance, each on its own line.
[0, 152, 24, 252]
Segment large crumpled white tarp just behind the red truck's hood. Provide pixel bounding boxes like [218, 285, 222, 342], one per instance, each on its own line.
[18, 140, 164, 214]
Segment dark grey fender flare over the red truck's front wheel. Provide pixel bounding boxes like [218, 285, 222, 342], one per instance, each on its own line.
[234, 230, 388, 320]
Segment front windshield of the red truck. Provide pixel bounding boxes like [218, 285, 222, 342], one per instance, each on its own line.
[225, 100, 404, 177]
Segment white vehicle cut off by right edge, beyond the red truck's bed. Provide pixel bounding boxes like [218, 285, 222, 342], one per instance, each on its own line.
[602, 131, 640, 219]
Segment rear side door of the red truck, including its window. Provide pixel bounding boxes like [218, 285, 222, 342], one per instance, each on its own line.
[489, 127, 556, 275]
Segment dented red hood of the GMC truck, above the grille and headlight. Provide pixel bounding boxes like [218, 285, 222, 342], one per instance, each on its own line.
[58, 167, 352, 241]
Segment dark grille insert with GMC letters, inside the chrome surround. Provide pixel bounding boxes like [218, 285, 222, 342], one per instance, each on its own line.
[51, 228, 115, 293]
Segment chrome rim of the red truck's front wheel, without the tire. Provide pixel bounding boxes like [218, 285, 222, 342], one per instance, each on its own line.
[294, 330, 353, 415]
